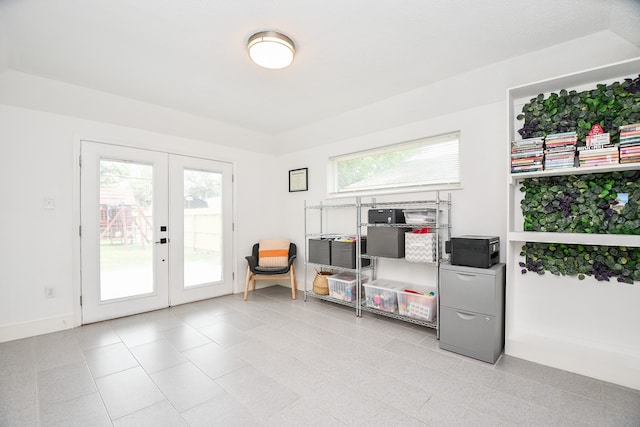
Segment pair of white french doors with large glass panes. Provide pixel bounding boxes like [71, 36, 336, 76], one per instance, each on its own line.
[80, 141, 233, 323]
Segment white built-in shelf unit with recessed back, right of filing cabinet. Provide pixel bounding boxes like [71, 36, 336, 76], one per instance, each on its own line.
[504, 58, 640, 388]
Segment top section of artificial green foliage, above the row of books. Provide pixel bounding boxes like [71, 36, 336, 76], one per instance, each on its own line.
[517, 75, 640, 145]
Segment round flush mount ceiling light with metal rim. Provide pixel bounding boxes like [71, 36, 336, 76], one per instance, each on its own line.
[247, 31, 296, 69]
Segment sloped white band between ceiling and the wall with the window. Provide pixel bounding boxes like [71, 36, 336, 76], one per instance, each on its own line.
[275, 31, 640, 153]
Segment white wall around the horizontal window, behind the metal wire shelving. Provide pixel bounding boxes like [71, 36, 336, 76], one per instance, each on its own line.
[281, 103, 508, 304]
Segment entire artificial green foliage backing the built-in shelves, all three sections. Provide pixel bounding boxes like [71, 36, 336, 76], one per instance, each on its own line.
[517, 75, 640, 283]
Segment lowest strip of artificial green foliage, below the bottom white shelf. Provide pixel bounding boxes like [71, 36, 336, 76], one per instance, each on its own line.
[520, 242, 640, 284]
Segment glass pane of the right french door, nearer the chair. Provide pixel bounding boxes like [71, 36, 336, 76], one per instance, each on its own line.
[183, 169, 222, 288]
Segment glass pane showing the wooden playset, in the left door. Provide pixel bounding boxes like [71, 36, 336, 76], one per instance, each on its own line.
[100, 159, 154, 301]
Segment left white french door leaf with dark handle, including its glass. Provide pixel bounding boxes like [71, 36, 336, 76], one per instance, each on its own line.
[80, 141, 170, 324]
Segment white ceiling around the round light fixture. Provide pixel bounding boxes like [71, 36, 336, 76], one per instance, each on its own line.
[0, 0, 640, 135]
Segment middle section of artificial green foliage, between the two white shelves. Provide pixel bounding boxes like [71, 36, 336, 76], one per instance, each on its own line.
[520, 171, 640, 234]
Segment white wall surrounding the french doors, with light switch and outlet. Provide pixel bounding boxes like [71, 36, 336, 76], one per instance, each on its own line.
[0, 105, 283, 342]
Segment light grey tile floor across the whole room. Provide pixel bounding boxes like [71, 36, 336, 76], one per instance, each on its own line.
[0, 286, 640, 427]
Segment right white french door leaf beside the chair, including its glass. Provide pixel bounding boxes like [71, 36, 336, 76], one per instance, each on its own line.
[169, 154, 233, 305]
